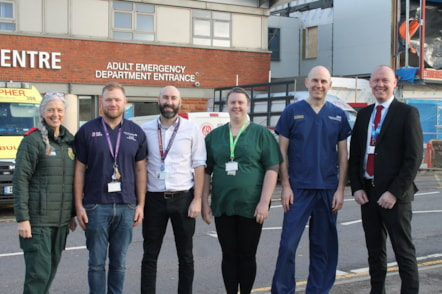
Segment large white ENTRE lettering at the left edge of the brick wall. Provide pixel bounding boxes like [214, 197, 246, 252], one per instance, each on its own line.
[0, 49, 61, 69]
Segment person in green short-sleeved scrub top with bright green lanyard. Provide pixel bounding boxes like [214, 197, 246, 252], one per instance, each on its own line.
[202, 87, 282, 294]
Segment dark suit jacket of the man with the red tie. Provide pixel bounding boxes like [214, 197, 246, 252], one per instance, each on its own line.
[348, 98, 423, 202]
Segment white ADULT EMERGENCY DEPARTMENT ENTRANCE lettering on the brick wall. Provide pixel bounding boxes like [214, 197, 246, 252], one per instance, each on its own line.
[95, 62, 198, 83]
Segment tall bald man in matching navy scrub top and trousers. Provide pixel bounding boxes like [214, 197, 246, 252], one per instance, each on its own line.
[272, 66, 351, 294]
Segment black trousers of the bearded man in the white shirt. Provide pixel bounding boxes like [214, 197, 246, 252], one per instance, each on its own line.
[141, 190, 195, 294]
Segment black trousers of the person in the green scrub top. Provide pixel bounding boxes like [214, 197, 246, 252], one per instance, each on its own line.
[215, 215, 262, 294]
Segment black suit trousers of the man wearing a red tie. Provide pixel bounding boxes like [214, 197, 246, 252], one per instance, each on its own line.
[361, 181, 419, 294]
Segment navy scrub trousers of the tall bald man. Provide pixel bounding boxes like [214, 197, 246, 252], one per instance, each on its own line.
[272, 189, 338, 294]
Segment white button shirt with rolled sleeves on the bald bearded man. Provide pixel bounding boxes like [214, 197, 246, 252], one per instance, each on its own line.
[141, 117, 207, 192]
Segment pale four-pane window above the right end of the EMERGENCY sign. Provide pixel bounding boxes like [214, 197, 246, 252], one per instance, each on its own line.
[192, 10, 231, 47]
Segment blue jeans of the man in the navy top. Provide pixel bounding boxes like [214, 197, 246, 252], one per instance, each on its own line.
[85, 204, 135, 294]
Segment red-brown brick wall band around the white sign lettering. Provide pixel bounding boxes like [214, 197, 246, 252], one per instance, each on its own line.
[0, 34, 270, 89]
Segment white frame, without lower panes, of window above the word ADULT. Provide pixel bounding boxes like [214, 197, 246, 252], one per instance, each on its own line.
[112, 1, 156, 42]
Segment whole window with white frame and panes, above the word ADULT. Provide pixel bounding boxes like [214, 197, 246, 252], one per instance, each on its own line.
[113, 1, 155, 41]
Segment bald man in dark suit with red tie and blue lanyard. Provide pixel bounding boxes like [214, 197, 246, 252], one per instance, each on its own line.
[349, 65, 423, 294]
